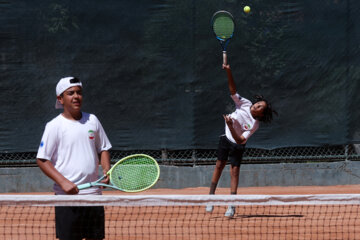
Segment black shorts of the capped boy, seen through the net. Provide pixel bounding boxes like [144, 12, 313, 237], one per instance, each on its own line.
[55, 206, 105, 239]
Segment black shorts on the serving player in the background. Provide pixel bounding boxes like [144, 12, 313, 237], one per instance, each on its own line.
[217, 135, 245, 167]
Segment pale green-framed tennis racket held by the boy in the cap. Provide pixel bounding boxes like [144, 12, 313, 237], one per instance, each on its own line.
[77, 154, 160, 192]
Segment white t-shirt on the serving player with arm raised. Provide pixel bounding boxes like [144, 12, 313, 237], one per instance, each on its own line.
[225, 93, 259, 143]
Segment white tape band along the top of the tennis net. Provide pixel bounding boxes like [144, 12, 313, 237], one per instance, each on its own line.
[0, 194, 360, 206]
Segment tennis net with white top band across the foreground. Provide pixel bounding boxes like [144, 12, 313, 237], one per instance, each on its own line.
[0, 194, 360, 240]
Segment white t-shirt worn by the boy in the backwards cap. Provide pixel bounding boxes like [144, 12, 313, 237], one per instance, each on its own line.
[36, 112, 111, 194]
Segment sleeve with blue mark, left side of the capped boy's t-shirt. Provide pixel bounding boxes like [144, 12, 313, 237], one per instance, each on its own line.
[36, 123, 58, 161]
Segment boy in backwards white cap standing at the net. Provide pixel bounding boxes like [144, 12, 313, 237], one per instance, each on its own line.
[36, 77, 111, 239]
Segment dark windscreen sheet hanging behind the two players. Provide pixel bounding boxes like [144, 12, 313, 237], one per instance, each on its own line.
[0, 0, 360, 152]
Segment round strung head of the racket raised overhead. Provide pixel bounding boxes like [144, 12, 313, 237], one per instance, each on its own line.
[213, 13, 235, 40]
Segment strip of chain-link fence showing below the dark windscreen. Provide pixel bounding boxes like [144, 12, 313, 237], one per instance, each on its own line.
[0, 145, 360, 167]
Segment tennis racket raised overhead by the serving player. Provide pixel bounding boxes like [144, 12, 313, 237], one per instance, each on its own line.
[211, 10, 235, 65]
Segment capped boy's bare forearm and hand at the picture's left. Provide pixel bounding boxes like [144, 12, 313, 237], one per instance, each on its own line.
[36, 158, 79, 194]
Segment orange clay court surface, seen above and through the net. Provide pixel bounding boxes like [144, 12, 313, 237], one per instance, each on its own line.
[0, 185, 360, 240]
